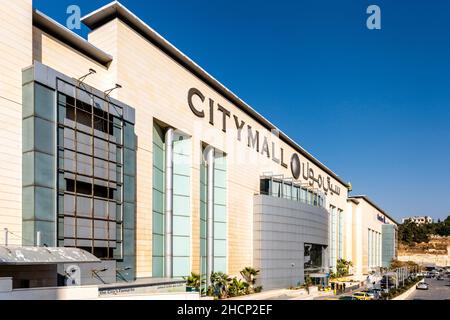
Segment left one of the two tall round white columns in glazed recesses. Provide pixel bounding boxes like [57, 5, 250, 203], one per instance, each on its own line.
[164, 128, 173, 278]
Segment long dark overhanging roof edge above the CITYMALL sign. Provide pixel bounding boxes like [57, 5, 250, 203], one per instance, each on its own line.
[81, 1, 351, 190]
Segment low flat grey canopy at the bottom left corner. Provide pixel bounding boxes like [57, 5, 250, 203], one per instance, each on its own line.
[0, 247, 101, 266]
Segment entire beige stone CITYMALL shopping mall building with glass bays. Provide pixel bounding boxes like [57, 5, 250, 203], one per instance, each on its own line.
[0, 0, 396, 289]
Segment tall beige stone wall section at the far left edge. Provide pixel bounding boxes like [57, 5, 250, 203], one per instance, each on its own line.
[0, 0, 32, 245]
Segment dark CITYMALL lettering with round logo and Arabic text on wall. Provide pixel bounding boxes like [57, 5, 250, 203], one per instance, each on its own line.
[188, 88, 341, 195]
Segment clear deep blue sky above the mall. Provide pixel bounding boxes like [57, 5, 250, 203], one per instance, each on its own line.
[34, 0, 450, 218]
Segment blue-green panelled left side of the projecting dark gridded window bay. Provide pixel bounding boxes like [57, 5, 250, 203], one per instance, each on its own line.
[22, 77, 57, 247]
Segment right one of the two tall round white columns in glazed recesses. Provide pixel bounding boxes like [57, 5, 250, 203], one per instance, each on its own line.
[206, 147, 214, 287]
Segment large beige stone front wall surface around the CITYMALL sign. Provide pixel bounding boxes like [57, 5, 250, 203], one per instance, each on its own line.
[90, 19, 347, 274]
